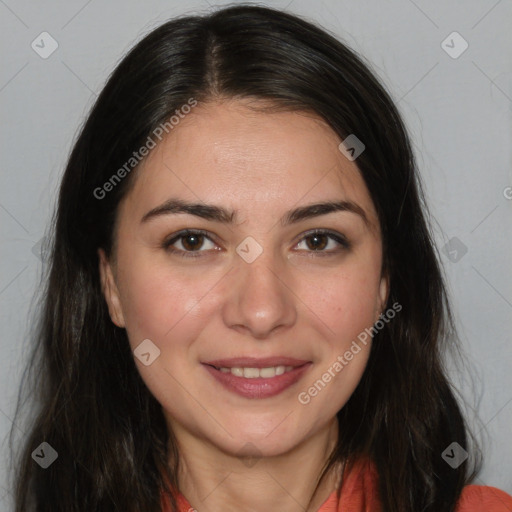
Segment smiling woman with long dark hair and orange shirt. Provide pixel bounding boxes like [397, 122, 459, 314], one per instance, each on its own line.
[9, 6, 512, 512]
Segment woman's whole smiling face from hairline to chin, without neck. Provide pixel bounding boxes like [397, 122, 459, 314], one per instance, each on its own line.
[100, 100, 387, 456]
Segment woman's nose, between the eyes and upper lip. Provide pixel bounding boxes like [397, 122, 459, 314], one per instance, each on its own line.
[223, 251, 297, 340]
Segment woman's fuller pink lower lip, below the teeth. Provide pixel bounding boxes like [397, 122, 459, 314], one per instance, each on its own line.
[204, 363, 312, 398]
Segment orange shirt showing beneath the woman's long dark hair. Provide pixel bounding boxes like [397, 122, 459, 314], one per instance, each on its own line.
[162, 462, 512, 512]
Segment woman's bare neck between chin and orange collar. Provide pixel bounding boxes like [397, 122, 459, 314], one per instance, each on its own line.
[171, 418, 339, 512]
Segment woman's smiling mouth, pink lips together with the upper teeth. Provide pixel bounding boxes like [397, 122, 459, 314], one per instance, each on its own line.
[202, 357, 313, 398]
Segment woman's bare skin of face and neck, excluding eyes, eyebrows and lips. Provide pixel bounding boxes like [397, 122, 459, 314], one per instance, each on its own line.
[98, 100, 388, 512]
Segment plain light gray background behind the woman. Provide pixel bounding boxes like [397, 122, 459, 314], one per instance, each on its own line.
[0, 0, 512, 511]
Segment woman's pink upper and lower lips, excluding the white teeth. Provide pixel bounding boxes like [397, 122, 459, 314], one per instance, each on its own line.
[203, 358, 313, 398]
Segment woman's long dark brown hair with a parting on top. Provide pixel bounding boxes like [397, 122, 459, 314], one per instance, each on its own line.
[11, 5, 479, 512]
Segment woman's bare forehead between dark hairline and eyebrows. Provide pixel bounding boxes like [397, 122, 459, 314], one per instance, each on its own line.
[118, 100, 376, 227]
